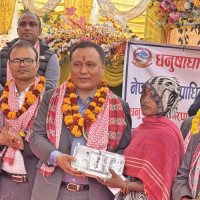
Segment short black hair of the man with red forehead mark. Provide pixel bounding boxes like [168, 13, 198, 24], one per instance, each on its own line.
[70, 41, 105, 64]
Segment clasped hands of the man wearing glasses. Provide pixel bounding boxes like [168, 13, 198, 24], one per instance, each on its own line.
[0, 123, 24, 150]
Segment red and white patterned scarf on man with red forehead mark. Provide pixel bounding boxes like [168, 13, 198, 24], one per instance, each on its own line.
[40, 82, 126, 176]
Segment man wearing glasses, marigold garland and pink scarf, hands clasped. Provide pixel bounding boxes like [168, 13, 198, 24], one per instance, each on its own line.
[0, 40, 45, 200]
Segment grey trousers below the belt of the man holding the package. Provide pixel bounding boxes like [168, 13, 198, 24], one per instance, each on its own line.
[57, 186, 89, 200]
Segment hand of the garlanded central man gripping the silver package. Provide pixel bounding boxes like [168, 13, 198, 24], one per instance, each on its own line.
[57, 154, 85, 177]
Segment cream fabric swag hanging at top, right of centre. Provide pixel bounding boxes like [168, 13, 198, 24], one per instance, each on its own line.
[97, 0, 149, 24]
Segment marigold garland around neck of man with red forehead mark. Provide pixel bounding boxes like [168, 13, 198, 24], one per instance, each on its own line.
[62, 79, 107, 137]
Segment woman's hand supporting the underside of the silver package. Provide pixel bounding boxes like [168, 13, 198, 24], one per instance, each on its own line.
[97, 169, 123, 188]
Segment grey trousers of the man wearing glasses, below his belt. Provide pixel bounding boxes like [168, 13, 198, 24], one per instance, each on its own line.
[0, 175, 31, 200]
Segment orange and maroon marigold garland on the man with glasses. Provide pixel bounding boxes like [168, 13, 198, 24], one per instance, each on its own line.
[1, 76, 46, 119]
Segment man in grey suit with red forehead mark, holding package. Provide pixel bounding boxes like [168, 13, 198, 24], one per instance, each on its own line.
[30, 42, 131, 200]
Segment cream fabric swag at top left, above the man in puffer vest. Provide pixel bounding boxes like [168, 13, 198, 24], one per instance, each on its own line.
[22, 0, 61, 16]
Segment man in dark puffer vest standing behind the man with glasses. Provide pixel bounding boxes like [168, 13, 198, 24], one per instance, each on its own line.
[0, 12, 59, 89]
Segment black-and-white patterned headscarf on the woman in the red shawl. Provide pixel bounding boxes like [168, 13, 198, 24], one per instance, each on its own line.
[142, 76, 180, 118]
